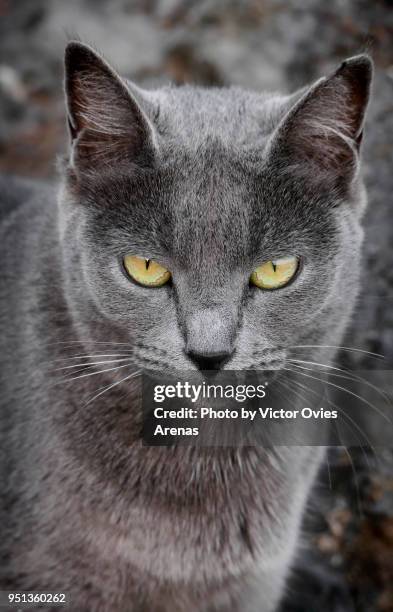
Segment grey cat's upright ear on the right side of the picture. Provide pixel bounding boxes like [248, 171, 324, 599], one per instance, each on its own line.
[270, 55, 373, 188]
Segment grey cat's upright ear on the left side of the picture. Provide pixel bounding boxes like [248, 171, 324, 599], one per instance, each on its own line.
[65, 42, 154, 171]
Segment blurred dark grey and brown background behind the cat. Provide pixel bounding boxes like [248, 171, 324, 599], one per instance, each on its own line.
[0, 0, 393, 612]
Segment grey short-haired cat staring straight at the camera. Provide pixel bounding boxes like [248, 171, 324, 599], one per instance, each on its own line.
[0, 42, 372, 612]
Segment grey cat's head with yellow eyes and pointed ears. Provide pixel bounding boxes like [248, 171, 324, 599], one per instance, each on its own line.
[60, 43, 372, 370]
